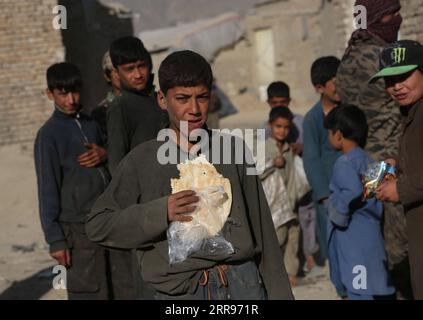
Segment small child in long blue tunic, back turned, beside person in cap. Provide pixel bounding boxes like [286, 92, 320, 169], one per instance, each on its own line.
[324, 105, 395, 300]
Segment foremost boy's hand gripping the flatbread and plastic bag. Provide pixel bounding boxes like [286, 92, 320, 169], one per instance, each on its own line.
[167, 190, 200, 222]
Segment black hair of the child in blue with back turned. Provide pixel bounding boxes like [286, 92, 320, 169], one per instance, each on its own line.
[324, 103, 369, 148]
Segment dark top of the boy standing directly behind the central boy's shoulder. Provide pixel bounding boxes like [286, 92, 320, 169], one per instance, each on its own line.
[107, 89, 167, 175]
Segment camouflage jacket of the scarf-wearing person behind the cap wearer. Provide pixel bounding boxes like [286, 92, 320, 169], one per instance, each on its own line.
[336, 38, 401, 161]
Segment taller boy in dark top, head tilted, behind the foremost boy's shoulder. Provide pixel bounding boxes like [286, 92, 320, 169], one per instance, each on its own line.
[107, 37, 167, 174]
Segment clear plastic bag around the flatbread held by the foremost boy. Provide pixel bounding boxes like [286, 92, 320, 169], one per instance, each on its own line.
[167, 186, 234, 265]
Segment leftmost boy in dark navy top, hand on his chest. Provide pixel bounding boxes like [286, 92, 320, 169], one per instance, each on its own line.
[34, 63, 109, 299]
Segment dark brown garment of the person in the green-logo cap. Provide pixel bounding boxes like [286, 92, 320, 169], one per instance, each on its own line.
[397, 99, 423, 299]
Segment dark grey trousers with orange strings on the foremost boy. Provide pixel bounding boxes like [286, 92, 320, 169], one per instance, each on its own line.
[155, 261, 267, 300]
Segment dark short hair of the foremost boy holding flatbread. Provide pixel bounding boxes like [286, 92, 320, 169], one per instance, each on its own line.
[159, 50, 213, 94]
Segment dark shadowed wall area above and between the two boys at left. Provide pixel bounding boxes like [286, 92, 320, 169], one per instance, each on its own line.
[58, 0, 134, 111]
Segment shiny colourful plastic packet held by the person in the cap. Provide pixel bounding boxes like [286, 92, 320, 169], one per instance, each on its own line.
[362, 161, 396, 199]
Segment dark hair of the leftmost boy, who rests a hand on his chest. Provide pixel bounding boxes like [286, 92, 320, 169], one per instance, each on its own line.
[46, 62, 82, 92]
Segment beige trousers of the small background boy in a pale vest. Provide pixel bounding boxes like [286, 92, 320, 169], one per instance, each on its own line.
[276, 220, 300, 276]
